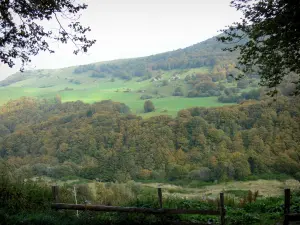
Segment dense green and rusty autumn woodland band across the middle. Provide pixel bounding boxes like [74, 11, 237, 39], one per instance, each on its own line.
[0, 96, 300, 182]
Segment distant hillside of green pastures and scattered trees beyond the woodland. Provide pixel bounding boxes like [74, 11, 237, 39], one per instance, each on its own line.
[0, 37, 259, 116]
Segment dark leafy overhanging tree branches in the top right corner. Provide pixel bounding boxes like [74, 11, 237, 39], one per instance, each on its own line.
[218, 0, 300, 94]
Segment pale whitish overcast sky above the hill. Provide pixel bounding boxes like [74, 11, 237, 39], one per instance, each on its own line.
[0, 0, 241, 80]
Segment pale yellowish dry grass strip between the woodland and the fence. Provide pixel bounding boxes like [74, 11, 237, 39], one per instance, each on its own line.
[33, 177, 300, 199]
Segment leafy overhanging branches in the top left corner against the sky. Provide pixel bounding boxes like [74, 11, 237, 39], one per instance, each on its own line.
[0, 0, 95, 70]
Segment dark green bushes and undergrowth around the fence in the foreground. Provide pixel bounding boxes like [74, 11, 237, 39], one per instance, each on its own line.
[0, 169, 300, 225]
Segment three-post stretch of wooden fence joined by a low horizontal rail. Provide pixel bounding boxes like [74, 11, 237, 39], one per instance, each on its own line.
[51, 186, 226, 225]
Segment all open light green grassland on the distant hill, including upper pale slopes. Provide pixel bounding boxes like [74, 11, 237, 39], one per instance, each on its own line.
[0, 67, 236, 117]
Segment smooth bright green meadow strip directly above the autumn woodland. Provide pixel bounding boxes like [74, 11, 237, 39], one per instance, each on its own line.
[0, 84, 230, 117]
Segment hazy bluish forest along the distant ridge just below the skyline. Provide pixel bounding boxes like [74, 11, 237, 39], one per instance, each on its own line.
[68, 35, 240, 82]
